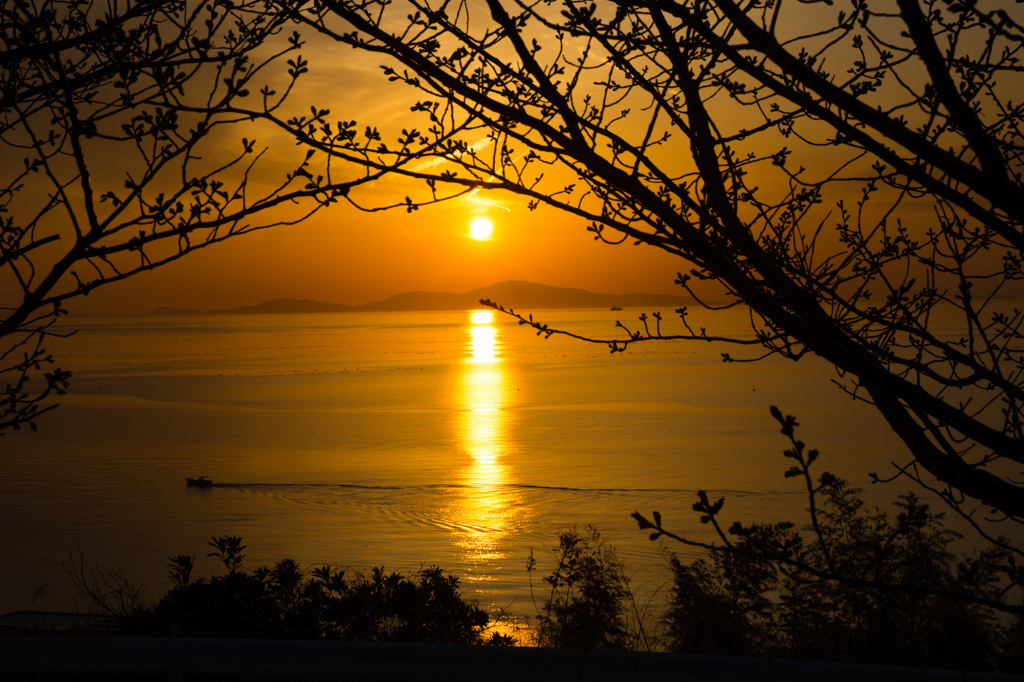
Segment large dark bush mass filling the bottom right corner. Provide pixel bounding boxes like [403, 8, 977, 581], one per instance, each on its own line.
[667, 477, 1020, 670]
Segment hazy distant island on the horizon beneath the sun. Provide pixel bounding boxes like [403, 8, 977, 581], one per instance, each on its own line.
[151, 281, 693, 315]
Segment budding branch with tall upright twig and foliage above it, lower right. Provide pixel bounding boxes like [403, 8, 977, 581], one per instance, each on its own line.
[633, 407, 1024, 614]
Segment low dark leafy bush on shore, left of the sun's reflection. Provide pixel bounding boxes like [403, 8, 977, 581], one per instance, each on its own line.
[124, 536, 491, 644]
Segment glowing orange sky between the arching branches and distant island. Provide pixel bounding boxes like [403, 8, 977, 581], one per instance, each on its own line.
[71, 191, 683, 312]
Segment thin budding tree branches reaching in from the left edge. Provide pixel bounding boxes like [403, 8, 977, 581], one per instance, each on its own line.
[0, 0, 468, 433]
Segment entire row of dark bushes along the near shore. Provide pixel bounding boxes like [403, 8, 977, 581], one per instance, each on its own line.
[59, 466, 1024, 672]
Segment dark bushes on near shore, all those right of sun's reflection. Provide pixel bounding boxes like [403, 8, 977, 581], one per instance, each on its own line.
[537, 485, 1024, 672]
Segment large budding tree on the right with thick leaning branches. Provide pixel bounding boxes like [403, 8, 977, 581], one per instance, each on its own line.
[276, 0, 1024, 544]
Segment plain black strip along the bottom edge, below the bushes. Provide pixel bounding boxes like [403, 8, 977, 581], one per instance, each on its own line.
[0, 636, 1024, 682]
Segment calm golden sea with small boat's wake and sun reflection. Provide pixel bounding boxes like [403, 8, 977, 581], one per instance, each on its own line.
[0, 309, 925, 620]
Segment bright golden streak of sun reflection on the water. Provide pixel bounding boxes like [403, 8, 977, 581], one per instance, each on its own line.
[454, 310, 523, 587]
